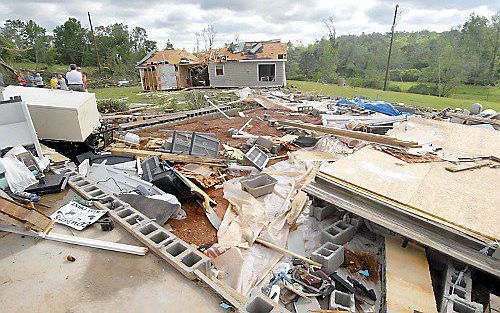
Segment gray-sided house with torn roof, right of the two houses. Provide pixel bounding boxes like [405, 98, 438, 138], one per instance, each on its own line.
[208, 40, 287, 87]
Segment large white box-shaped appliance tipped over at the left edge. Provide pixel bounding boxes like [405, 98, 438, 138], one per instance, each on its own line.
[3, 86, 100, 142]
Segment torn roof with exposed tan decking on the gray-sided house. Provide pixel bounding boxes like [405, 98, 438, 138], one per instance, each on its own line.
[219, 40, 287, 61]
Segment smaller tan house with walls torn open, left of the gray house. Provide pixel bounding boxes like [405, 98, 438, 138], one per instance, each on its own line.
[136, 49, 206, 91]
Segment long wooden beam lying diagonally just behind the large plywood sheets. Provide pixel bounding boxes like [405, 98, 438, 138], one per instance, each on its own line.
[278, 121, 421, 148]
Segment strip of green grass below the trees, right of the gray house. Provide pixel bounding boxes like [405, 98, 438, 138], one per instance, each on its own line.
[287, 80, 500, 111]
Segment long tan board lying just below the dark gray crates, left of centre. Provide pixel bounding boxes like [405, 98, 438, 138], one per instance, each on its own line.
[110, 148, 227, 167]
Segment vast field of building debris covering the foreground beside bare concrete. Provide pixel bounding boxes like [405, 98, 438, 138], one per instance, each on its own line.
[0, 87, 500, 313]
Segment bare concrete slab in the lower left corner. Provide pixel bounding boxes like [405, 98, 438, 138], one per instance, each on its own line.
[0, 192, 224, 313]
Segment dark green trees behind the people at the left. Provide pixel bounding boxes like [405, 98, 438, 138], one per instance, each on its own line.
[0, 18, 157, 78]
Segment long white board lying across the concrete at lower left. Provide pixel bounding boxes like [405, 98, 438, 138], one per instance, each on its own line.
[0, 224, 148, 255]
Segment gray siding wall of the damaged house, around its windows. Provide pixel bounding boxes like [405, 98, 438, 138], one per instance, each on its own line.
[208, 60, 286, 87]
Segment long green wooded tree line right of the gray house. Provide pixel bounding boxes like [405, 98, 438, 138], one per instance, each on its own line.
[287, 13, 500, 96]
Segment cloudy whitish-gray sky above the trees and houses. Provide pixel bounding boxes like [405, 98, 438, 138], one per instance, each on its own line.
[0, 0, 500, 50]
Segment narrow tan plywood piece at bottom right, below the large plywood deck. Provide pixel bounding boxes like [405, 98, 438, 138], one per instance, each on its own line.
[385, 237, 437, 313]
